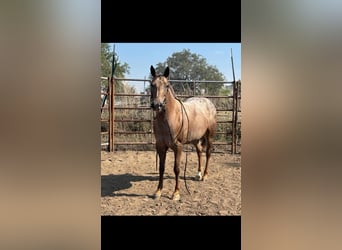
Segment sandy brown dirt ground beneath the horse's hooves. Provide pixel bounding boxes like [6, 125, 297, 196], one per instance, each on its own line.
[101, 151, 241, 216]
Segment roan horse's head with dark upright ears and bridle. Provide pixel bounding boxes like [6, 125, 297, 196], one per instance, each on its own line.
[150, 65, 170, 112]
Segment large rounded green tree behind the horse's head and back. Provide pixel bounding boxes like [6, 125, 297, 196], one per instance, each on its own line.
[151, 49, 224, 95]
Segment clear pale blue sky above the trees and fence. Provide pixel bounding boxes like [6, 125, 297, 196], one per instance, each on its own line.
[110, 43, 241, 93]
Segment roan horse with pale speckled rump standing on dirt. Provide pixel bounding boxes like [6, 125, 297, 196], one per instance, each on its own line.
[150, 65, 217, 200]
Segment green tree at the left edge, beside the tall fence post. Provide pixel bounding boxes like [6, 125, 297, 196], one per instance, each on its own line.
[101, 43, 129, 92]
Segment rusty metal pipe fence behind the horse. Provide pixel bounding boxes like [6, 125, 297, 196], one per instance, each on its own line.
[100, 77, 241, 154]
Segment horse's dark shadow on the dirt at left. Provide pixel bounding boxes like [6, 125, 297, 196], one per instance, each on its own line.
[101, 173, 174, 197]
